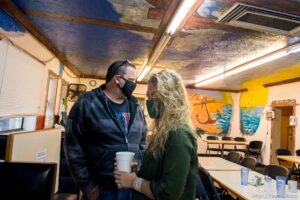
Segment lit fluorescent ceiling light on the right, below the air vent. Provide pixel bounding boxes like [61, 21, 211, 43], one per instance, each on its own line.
[195, 43, 300, 87]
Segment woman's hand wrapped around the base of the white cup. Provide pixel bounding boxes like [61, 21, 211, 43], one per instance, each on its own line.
[114, 170, 137, 189]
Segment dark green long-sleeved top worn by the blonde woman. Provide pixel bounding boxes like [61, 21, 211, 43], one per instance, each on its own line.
[132, 125, 198, 200]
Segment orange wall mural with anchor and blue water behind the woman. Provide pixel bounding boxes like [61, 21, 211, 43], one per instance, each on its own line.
[188, 90, 232, 135]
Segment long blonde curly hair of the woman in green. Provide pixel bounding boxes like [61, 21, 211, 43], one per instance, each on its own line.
[148, 69, 197, 158]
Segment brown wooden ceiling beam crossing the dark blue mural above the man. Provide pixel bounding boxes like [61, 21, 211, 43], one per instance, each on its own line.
[22, 9, 157, 34]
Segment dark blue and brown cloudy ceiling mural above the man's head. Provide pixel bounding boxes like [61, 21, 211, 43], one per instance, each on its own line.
[7, 0, 160, 77]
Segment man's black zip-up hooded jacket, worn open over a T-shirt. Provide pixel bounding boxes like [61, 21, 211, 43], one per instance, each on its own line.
[64, 85, 146, 193]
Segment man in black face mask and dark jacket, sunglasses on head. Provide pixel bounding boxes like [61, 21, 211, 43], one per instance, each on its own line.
[64, 60, 146, 200]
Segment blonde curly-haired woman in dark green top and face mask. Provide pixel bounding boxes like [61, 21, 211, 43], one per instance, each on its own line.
[115, 70, 198, 200]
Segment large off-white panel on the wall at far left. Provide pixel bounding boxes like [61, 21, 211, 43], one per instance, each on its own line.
[0, 41, 45, 117]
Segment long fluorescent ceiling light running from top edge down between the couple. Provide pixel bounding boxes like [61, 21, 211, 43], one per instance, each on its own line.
[137, 0, 196, 81]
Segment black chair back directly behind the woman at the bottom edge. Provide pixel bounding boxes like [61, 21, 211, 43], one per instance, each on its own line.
[198, 166, 221, 200]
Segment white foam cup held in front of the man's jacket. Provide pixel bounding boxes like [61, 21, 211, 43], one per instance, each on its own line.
[116, 151, 134, 173]
